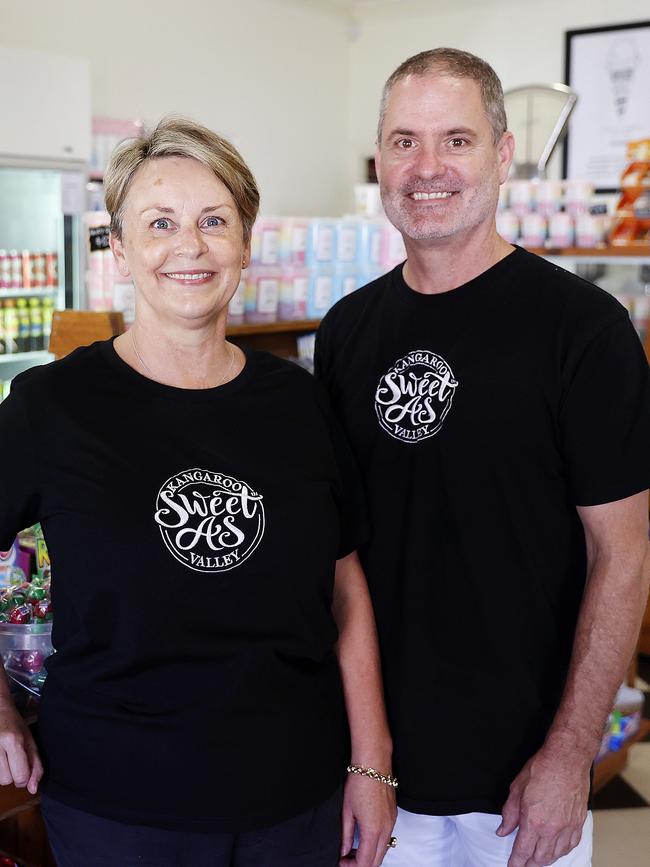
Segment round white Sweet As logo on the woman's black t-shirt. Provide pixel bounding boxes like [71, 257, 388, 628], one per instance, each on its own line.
[154, 469, 264, 572]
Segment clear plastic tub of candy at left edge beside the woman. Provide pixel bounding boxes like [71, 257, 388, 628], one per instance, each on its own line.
[0, 622, 54, 693]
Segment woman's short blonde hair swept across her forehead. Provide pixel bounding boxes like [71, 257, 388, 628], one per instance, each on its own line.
[104, 117, 260, 244]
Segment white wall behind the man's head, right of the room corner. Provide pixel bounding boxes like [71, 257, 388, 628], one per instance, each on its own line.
[349, 0, 650, 180]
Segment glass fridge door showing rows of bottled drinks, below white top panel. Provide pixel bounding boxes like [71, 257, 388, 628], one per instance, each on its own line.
[0, 166, 79, 398]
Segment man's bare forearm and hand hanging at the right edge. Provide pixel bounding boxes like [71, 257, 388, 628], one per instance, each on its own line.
[497, 491, 650, 867]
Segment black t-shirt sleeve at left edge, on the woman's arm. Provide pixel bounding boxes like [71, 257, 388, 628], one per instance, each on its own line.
[0, 389, 39, 551]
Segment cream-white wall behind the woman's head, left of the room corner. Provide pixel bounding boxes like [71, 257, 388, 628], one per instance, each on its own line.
[0, 0, 351, 215]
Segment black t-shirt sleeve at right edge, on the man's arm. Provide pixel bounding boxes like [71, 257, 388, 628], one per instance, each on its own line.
[560, 316, 650, 506]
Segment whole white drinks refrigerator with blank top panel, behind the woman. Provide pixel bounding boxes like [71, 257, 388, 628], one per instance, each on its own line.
[0, 45, 91, 398]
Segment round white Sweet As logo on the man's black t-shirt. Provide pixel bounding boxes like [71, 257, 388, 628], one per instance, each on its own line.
[375, 350, 458, 443]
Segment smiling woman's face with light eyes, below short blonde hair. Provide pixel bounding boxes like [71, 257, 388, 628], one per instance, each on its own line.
[111, 157, 248, 326]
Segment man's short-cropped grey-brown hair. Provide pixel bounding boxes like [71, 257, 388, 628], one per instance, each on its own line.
[377, 48, 508, 144]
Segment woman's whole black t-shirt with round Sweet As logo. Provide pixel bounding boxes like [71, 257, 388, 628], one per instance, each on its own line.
[0, 342, 365, 831]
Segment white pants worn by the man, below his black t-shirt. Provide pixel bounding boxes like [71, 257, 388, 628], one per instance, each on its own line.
[383, 809, 593, 867]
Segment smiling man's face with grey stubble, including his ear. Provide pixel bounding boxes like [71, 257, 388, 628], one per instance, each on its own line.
[376, 73, 513, 241]
